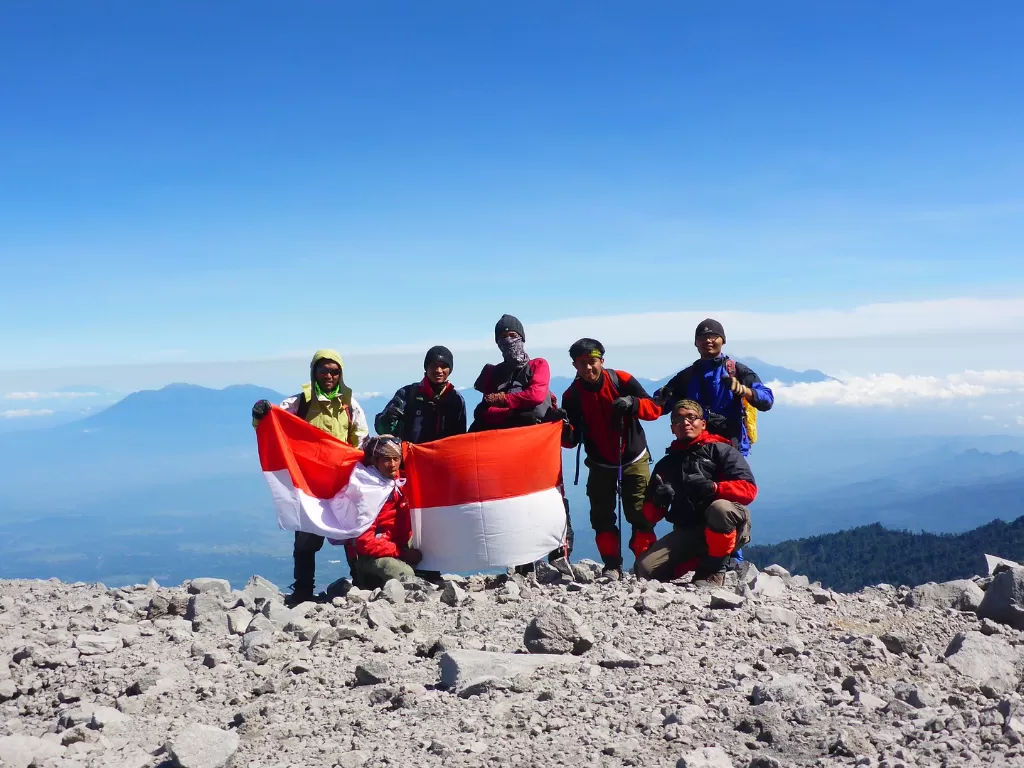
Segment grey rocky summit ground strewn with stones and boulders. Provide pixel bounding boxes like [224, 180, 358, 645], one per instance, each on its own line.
[0, 563, 1024, 768]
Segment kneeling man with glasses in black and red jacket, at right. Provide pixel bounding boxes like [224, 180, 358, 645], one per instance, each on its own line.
[636, 400, 758, 586]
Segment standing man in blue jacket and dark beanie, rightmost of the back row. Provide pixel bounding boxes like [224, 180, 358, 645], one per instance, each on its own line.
[654, 317, 775, 456]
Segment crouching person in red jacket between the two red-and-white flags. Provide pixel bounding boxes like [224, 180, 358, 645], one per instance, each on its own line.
[345, 435, 423, 589]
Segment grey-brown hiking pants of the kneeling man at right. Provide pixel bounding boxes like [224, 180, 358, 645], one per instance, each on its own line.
[636, 499, 751, 582]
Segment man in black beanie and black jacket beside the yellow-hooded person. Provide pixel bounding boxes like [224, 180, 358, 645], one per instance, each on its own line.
[374, 346, 466, 444]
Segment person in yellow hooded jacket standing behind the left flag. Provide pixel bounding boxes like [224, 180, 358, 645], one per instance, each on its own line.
[253, 349, 370, 605]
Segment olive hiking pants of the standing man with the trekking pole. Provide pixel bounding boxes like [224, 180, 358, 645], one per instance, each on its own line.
[587, 452, 654, 567]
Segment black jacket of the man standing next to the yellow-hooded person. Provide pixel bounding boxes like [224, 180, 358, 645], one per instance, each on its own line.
[374, 379, 466, 444]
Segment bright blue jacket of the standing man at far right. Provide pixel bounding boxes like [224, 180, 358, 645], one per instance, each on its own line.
[654, 355, 775, 456]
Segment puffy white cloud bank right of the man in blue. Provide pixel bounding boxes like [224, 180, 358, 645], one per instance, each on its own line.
[771, 371, 1024, 409]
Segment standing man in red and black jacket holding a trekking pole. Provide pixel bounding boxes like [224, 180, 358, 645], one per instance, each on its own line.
[562, 339, 662, 580]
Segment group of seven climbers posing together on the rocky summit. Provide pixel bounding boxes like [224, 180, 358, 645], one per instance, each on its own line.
[252, 314, 773, 602]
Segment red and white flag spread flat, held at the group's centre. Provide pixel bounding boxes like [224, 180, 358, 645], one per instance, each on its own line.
[406, 423, 566, 571]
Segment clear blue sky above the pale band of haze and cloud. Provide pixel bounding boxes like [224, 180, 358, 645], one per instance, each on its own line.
[0, 0, 1024, 373]
